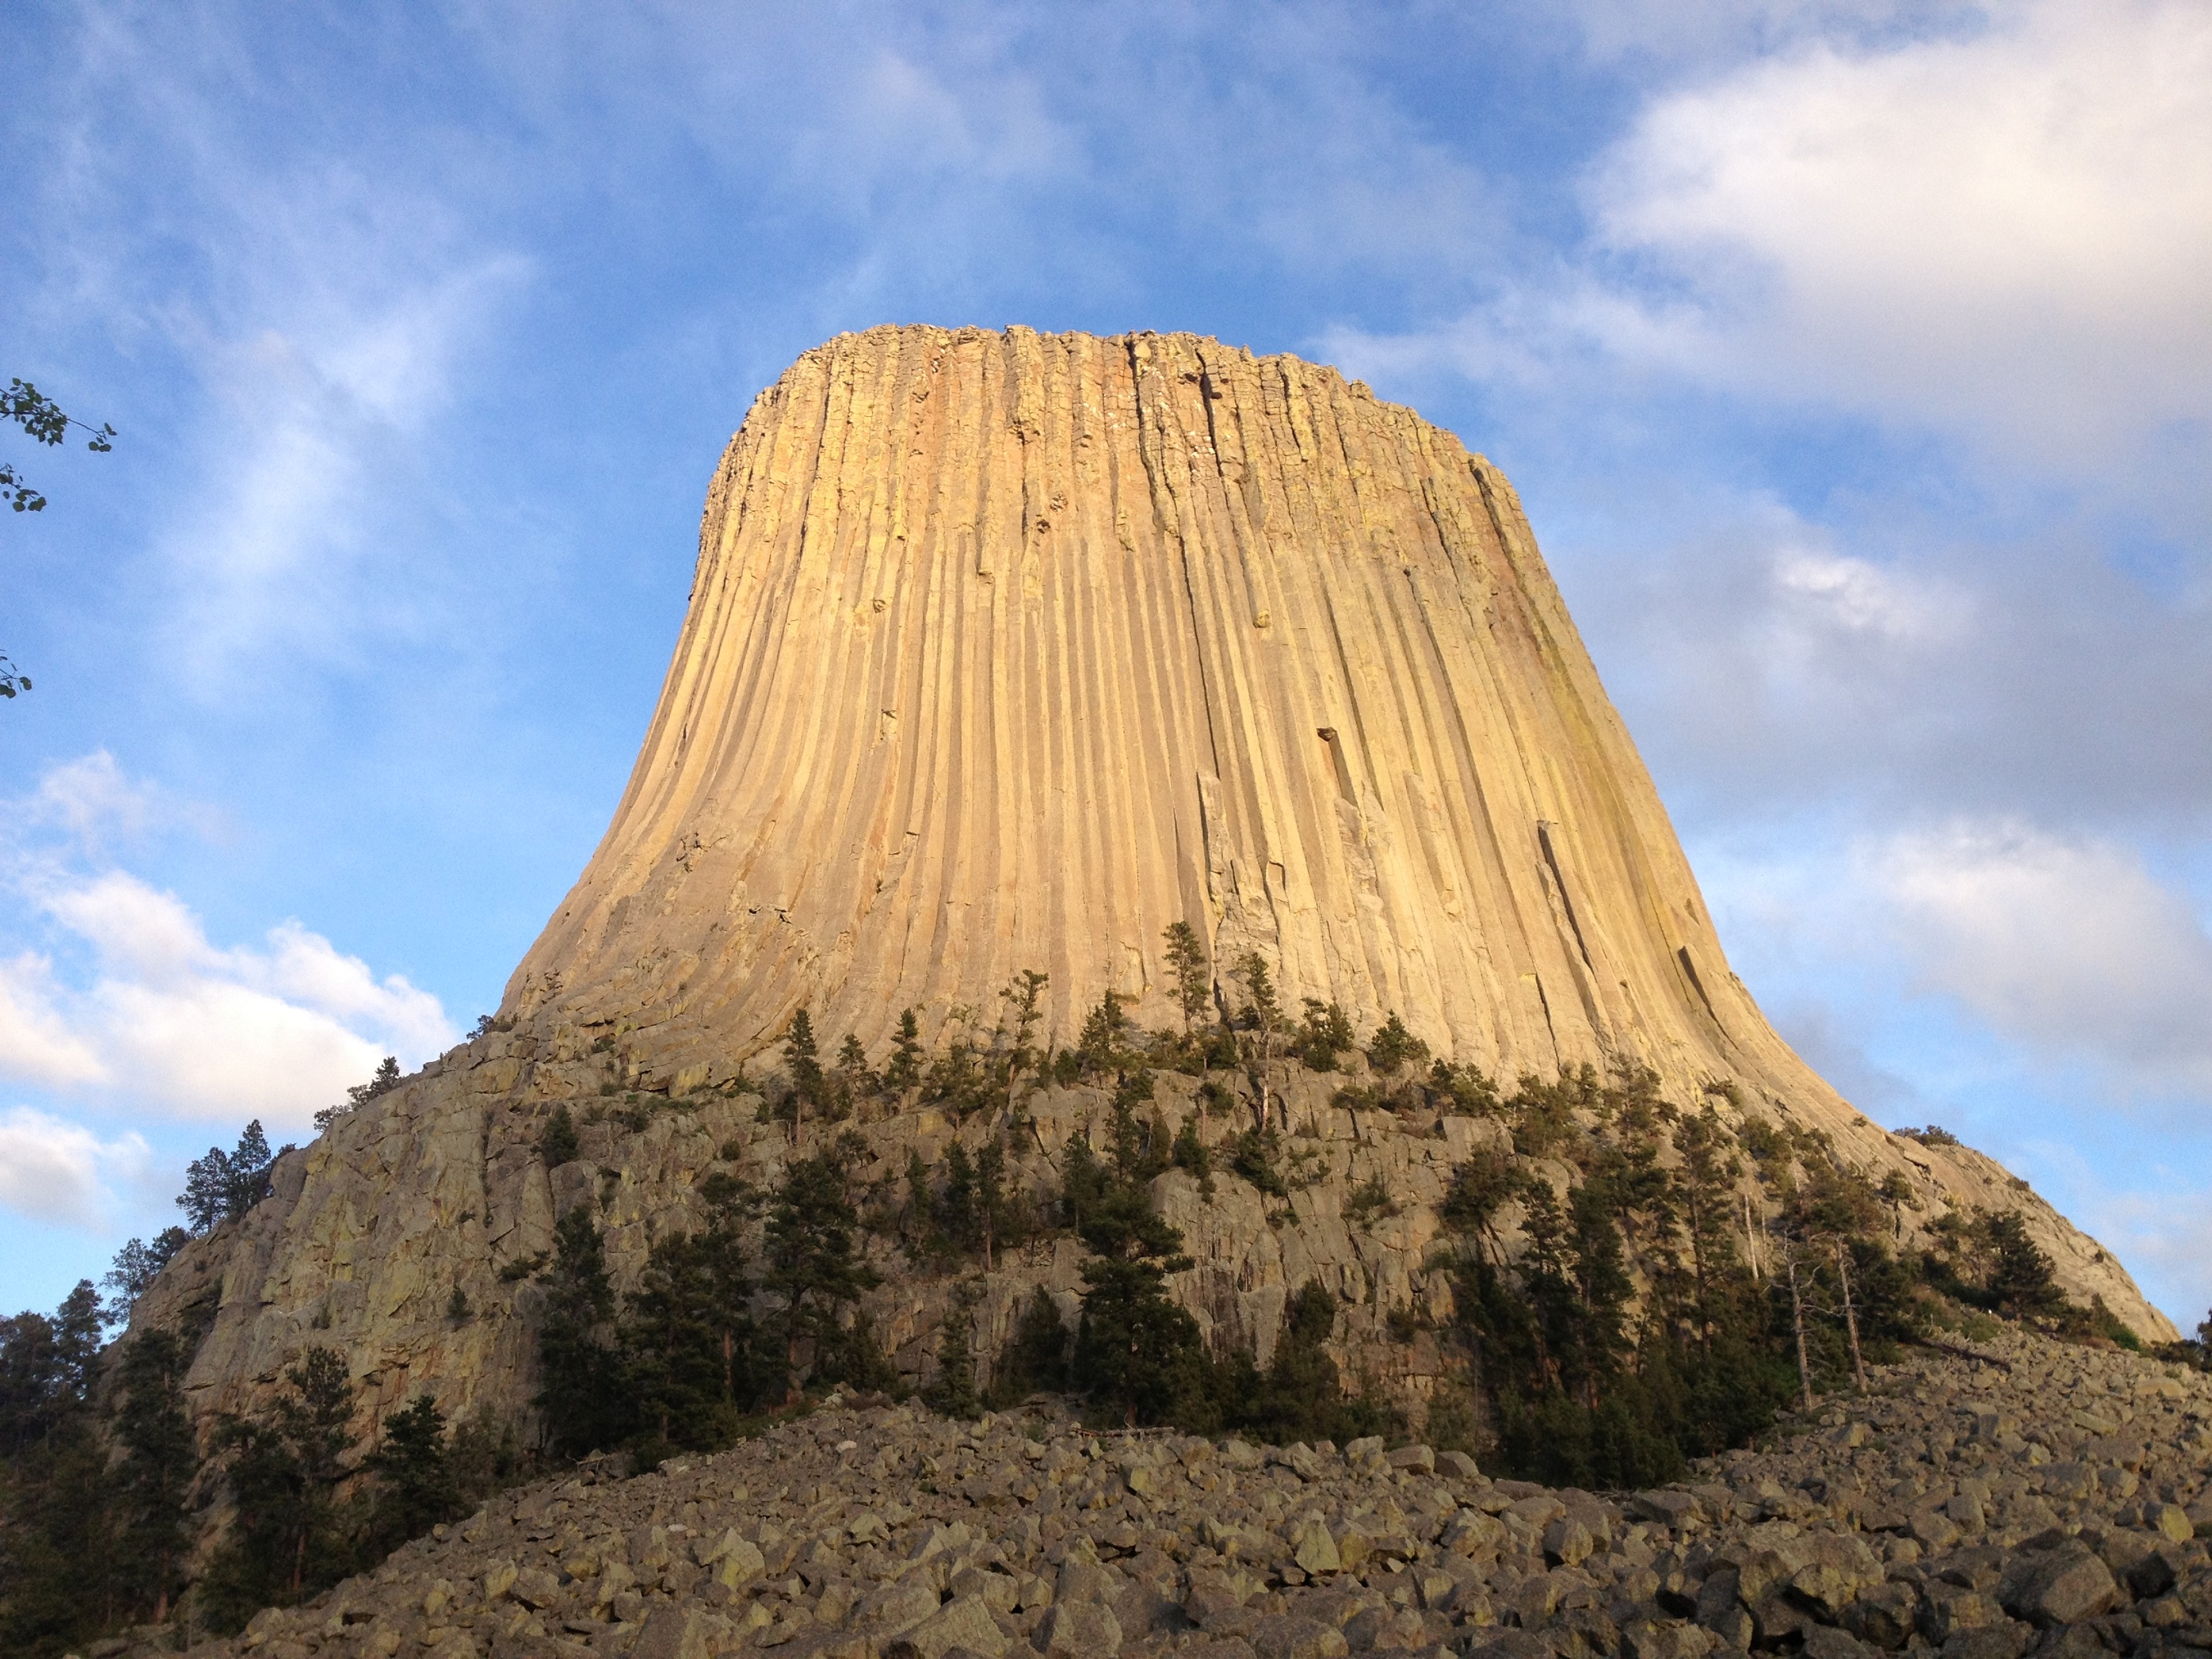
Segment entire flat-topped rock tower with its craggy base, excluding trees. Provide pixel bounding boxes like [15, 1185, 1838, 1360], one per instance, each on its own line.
[137, 328, 2175, 1451]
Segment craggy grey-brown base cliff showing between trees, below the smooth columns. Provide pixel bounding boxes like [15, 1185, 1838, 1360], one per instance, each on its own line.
[133, 1033, 2175, 1460]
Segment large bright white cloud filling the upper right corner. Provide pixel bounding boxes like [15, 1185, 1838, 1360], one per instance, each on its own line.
[1566, 0, 2212, 460]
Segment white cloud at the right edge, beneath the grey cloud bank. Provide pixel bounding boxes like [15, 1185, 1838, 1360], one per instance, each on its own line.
[1858, 823, 2212, 1097]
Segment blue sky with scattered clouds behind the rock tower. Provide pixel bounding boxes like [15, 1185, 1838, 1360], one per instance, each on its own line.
[0, 0, 2212, 1325]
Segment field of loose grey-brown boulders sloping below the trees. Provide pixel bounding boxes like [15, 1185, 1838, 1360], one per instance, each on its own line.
[160, 1336, 2212, 1659]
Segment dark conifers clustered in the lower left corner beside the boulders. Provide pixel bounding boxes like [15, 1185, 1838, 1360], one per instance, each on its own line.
[0, 1281, 517, 1657]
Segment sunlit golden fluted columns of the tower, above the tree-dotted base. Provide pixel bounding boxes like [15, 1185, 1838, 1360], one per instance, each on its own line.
[506, 328, 1813, 1122]
